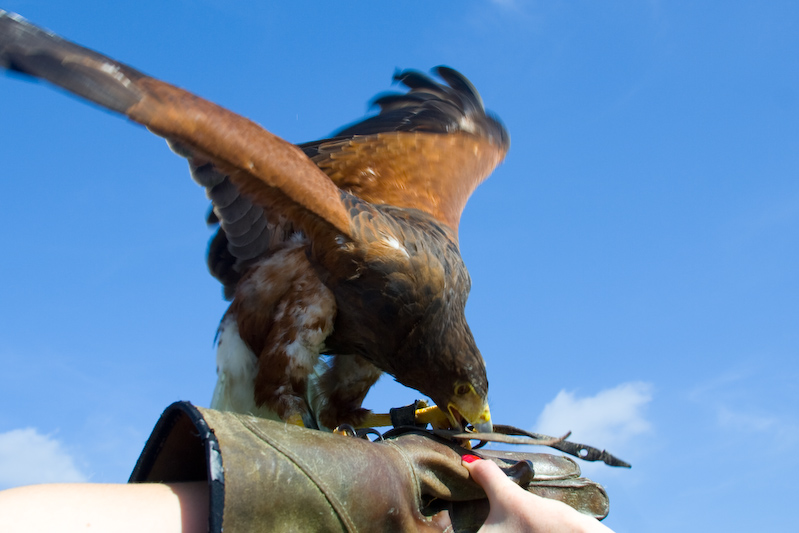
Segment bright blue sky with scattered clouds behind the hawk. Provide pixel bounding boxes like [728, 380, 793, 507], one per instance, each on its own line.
[0, 0, 799, 532]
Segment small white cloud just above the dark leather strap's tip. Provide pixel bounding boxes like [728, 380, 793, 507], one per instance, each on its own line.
[536, 382, 652, 453]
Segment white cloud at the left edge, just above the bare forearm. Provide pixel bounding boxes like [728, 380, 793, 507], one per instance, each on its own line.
[0, 428, 87, 489]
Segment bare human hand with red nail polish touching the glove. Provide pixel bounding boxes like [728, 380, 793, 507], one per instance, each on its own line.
[463, 455, 613, 533]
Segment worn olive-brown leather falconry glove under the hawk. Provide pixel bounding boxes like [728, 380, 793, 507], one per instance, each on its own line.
[130, 402, 608, 532]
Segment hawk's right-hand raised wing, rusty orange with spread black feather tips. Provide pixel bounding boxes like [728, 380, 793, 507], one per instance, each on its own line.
[300, 67, 510, 233]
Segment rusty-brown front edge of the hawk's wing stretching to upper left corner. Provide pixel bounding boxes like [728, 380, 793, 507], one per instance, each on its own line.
[0, 11, 352, 244]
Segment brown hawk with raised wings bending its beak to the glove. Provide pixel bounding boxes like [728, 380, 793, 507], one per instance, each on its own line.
[0, 11, 509, 432]
